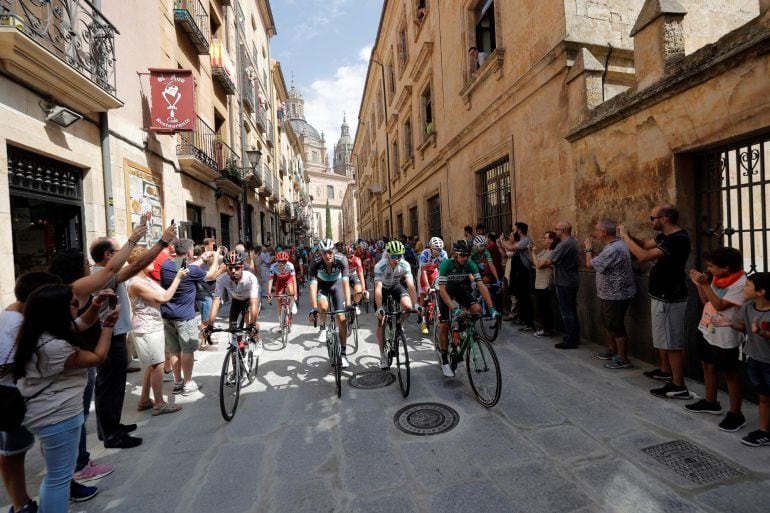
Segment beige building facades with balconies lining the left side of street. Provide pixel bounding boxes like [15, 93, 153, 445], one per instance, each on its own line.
[0, 0, 303, 305]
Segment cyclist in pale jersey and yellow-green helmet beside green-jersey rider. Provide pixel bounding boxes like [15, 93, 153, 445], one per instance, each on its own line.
[374, 240, 422, 370]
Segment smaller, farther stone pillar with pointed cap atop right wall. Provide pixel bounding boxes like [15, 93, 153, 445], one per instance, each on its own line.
[567, 48, 604, 127]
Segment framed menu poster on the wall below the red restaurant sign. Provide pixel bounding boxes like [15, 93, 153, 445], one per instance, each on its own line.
[123, 160, 164, 247]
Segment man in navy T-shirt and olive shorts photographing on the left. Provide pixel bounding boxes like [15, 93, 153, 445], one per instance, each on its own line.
[160, 239, 219, 395]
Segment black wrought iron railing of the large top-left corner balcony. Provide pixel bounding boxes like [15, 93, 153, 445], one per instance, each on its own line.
[0, 0, 118, 95]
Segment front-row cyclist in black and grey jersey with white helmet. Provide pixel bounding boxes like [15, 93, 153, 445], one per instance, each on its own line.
[309, 239, 351, 369]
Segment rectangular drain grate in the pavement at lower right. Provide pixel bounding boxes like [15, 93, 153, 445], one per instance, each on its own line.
[642, 440, 743, 485]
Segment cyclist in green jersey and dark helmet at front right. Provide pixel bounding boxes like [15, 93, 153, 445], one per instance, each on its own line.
[438, 240, 500, 378]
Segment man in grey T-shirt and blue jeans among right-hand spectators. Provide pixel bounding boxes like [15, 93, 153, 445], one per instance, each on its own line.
[542, 221, 580, 349]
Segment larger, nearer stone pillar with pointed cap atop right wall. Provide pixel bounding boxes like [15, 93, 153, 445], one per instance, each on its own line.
[631, 0, 684, 90]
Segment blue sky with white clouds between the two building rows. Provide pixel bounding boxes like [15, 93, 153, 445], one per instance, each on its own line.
[270, 0, 382, 153]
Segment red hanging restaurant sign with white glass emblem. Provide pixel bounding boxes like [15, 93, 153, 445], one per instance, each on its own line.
[150, 68, 195, 132]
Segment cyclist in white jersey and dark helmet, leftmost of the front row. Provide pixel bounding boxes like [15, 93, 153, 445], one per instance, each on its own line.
[205, 251, 262, 355]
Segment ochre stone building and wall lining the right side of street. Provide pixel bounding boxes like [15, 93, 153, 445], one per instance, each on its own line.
[353, 0, 770, 366]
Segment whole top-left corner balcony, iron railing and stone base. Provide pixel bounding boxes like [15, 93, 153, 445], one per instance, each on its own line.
[0, 0, 123, 112]
